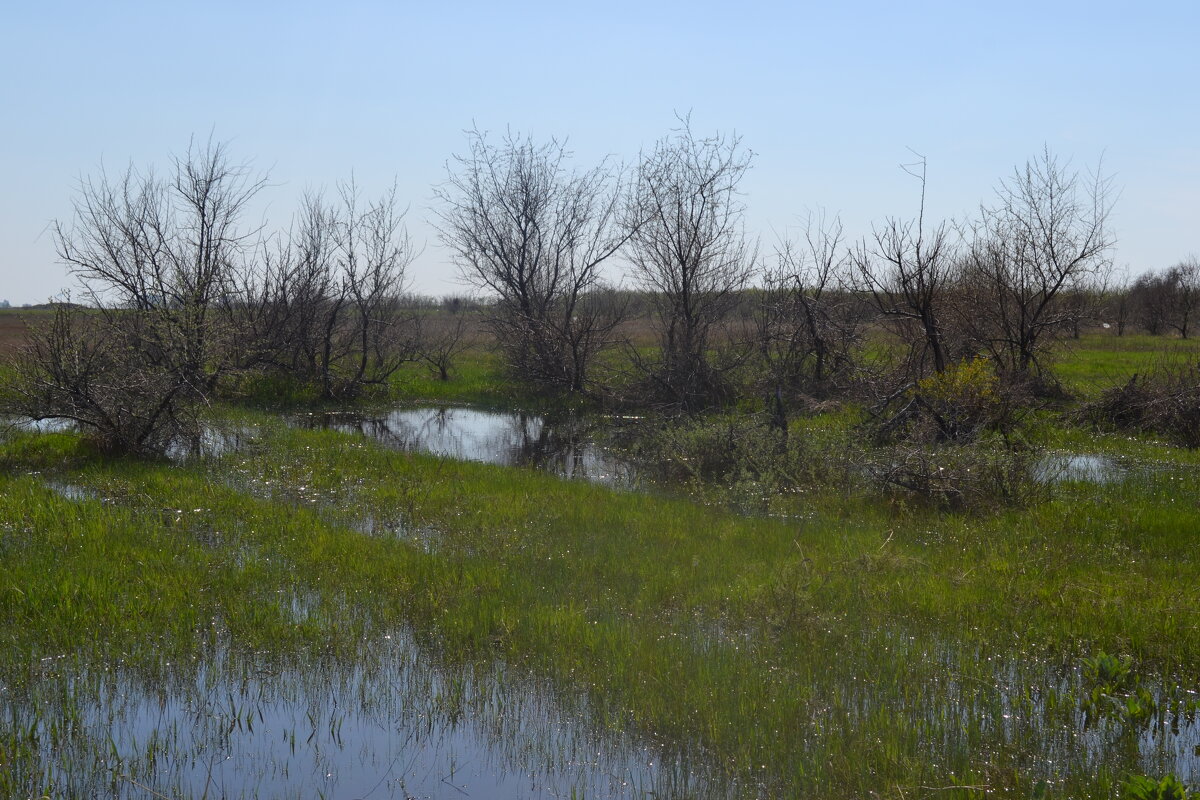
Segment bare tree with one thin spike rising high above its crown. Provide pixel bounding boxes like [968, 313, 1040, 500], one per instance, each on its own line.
[851, 156, 958, 378]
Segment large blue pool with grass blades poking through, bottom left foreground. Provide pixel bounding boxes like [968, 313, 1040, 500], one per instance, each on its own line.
[0, 633, 730, 799]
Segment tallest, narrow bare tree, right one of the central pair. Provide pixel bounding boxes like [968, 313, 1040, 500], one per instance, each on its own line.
[625, 118, 757, 409]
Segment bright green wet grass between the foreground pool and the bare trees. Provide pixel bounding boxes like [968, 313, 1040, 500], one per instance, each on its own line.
[0, 407, 1200, 798]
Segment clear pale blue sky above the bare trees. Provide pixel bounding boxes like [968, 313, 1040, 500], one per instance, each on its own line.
[0, 0, 1200, 305]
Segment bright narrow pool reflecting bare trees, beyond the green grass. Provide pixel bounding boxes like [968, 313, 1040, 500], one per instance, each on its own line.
[294, 408, 636, 487]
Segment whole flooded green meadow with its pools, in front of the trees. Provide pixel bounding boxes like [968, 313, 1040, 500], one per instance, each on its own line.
[0, 409, 1200, 798]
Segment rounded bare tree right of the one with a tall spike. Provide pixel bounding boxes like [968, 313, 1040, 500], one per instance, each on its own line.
[964, 149, 1114, 374]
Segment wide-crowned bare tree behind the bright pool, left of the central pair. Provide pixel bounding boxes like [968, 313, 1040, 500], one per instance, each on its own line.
[434, 131, 629, 392]
